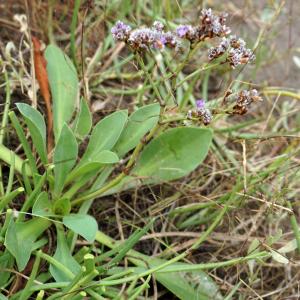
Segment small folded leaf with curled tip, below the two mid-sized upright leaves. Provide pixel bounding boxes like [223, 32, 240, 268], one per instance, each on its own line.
[67, 150, 119, 183]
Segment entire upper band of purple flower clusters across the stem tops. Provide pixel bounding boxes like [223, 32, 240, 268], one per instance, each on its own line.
[111, 8, 255, 69]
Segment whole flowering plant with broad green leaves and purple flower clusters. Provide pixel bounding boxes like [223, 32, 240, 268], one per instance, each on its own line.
[0, 9, 265, 299]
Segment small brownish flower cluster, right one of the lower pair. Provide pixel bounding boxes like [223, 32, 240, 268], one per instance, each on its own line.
[233, 89, 262, 115]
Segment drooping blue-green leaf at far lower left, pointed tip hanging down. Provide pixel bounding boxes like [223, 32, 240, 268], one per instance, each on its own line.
[4, 218, 51, 272]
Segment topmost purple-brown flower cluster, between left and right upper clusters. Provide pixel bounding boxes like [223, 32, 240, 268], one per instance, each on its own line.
[176, 8, 230, 43]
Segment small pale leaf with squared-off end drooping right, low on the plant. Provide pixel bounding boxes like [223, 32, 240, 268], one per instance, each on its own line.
[63, 214, 98, 243]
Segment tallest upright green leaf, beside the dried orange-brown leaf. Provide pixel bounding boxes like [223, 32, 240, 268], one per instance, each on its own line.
[45, 45, 79, 141]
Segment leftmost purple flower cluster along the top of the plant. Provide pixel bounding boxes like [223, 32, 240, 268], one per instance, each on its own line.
[111, 21, 179, 50]
